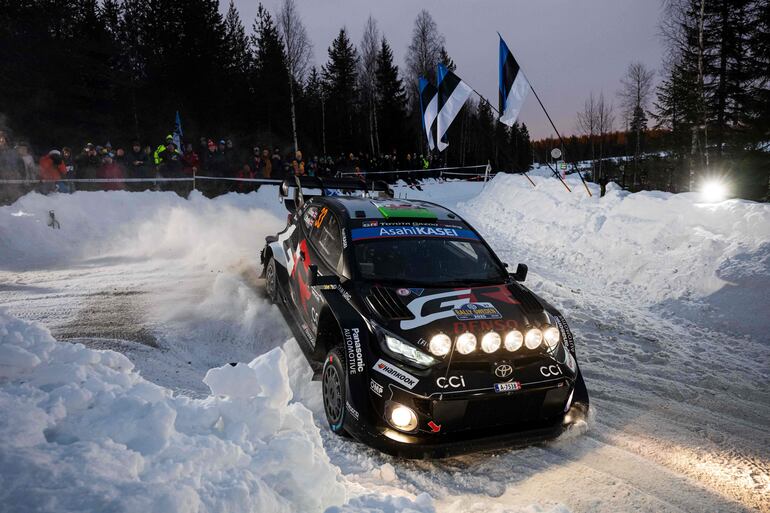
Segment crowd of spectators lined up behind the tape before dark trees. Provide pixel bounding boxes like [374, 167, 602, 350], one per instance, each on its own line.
[0, 132, 448, 203]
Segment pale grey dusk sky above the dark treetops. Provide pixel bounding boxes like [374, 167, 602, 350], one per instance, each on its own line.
[222, 0, 662, 138]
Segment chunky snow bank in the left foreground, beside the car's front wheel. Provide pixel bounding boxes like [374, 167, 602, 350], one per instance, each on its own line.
[0, 312, 345, 512]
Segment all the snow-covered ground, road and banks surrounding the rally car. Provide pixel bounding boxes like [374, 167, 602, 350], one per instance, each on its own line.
[0, 175, 770, 513]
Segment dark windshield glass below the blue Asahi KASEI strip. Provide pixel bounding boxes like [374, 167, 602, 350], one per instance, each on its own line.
[354, 237, 508, 287]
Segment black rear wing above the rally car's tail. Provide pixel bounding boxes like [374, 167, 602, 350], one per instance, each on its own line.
[278, 176, 393, 212]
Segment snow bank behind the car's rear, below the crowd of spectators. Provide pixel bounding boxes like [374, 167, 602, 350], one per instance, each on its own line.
[0, 187, 286, 270]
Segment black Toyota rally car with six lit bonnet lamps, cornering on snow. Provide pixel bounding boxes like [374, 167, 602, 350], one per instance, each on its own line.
[261, 177, 588, 457]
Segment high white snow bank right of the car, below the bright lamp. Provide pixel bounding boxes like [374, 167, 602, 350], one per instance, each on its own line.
[462, 175, 770, 339]
